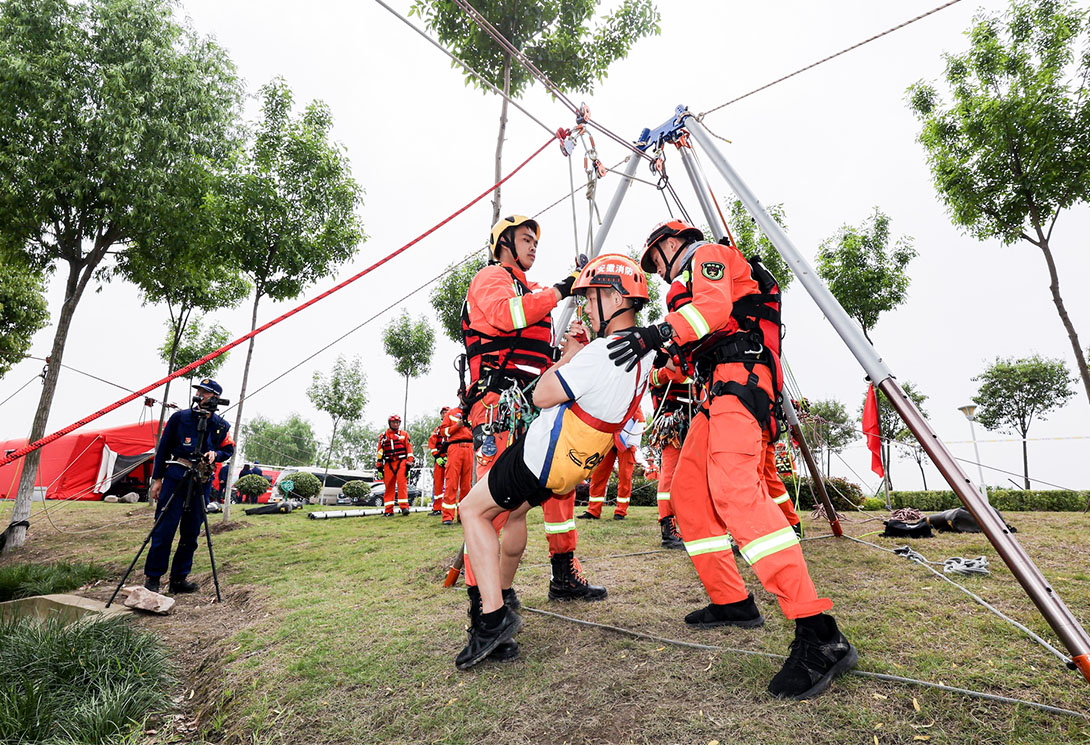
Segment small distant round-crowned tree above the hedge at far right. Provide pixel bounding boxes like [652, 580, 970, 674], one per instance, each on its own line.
[972, 355, 1076, 490]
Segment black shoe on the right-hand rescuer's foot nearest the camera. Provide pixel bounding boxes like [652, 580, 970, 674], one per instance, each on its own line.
[768, 613, 859, 700]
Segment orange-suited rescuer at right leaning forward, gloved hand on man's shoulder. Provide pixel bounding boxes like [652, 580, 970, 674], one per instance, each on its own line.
[609, 220, 858, 699]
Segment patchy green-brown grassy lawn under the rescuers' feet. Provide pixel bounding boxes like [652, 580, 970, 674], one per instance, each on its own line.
[7, 504, 1090, 745]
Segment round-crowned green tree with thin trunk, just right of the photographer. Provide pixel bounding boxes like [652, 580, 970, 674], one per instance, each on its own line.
[213, 79, 365, 520]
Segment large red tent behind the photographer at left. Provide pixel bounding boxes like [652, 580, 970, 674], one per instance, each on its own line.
[0, 421, 158, 500]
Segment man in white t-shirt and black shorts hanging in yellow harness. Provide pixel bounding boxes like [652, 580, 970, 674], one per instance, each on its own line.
[455, 254, 652, 670]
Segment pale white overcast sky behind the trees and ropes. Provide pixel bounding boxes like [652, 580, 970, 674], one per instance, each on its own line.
[0, 0, 1090, 497]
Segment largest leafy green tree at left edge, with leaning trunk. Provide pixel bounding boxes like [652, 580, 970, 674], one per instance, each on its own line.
[0, 0, 241, 548]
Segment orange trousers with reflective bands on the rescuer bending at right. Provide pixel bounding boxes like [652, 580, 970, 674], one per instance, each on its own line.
[670, 363, 833, 618]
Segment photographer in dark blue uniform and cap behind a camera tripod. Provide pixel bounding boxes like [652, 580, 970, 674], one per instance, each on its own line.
[144, 377, 234, 592]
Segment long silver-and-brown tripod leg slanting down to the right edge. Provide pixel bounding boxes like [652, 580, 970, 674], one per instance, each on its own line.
[681, 115, 1090, 682]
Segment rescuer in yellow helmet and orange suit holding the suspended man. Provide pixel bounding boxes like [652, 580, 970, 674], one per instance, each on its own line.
[462, 215, 606, 623]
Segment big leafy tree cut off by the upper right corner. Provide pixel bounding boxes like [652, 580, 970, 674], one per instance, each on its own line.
[909, 0, 1090, 400]
